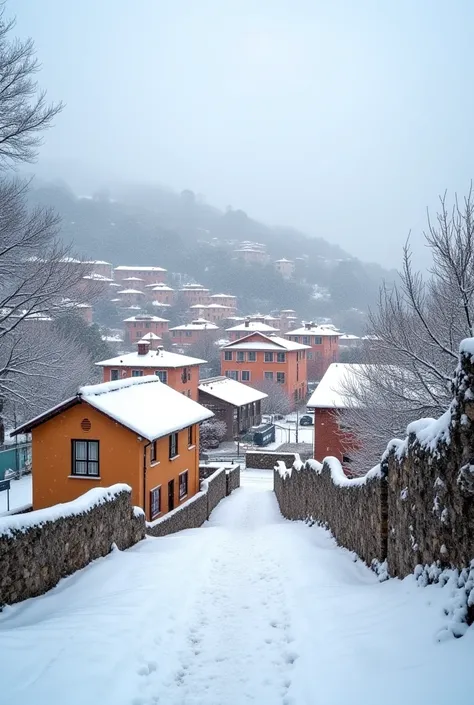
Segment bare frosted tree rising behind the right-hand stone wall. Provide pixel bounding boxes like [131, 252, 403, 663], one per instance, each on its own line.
[343, 186, 474, 473]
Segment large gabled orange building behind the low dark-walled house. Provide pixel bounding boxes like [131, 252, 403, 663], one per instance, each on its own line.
[221, 333, 309, 407]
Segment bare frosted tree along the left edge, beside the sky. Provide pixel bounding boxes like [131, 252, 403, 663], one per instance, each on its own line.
[0, 8, 96, 443]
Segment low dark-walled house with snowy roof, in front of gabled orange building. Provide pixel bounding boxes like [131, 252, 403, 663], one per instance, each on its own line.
[198, 377, 267, 441]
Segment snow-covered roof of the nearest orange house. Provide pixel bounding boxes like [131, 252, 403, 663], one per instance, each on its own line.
[79, 375, 214, 441]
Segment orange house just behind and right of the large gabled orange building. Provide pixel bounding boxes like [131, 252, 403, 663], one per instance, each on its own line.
[285, 323, 340, 381]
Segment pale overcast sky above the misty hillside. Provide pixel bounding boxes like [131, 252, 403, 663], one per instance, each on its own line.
[7, 0, 474, 266]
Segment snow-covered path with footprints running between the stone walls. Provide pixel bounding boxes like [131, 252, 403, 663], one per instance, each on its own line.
[0, 471, 474, 705]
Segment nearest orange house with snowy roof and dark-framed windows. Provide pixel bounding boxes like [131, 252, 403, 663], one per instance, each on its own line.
[14, 377, 213, 521]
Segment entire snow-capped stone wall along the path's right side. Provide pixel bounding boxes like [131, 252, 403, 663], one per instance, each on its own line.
[275, 339, 474, 576]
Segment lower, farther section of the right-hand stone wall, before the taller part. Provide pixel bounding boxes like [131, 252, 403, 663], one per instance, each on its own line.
[274, 458, 387, 565]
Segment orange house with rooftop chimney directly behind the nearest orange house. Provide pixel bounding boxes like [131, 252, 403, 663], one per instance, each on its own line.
[96, 334, 205, 401]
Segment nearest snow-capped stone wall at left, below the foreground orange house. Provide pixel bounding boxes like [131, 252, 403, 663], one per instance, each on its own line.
[0, 485, 145, 605]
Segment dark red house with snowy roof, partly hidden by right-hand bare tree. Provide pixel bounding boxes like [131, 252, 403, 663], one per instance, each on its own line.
[307, 362, 361, 467]
